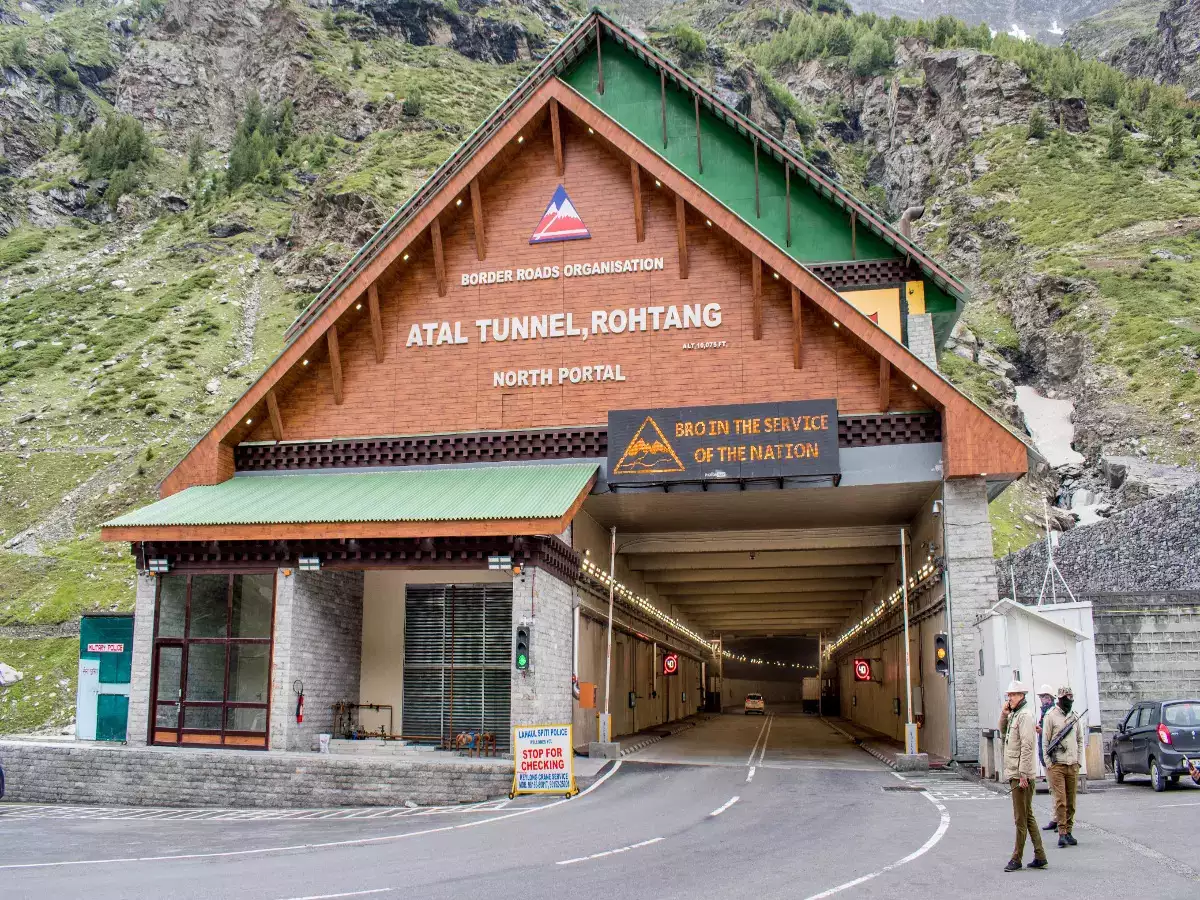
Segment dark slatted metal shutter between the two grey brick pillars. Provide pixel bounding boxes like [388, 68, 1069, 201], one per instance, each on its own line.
[402, 584, 512, 749]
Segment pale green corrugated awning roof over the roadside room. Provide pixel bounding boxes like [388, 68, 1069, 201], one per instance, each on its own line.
[103, 462, 596, 528]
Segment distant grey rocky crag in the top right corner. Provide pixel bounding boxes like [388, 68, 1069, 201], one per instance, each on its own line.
[1064, 0, 1200, 100]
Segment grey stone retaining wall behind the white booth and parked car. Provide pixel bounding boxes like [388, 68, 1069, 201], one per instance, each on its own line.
[996, 486, 1200, 736]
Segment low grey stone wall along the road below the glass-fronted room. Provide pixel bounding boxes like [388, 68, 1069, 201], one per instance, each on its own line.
[0, 742, 512, 808]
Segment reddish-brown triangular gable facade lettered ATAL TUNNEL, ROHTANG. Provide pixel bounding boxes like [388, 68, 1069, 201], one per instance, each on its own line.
[150, 13, 1026, 508]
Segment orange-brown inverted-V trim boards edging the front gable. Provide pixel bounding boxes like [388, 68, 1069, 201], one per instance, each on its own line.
[154, 17, 1026, 504]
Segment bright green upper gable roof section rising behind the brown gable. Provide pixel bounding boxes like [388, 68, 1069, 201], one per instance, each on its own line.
[287, 11, 967, 347]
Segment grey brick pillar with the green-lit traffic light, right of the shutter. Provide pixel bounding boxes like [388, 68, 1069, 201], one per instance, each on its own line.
[512, 569, 574, 725]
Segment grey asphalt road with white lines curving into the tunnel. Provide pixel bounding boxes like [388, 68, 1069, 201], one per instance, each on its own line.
[0, 714, 1200, 900]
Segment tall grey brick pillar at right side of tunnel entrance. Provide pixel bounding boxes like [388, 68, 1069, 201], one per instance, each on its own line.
[942, 478, 1000, 761]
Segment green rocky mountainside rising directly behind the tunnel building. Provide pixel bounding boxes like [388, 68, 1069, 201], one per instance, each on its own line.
[0, 0, 1200, 732]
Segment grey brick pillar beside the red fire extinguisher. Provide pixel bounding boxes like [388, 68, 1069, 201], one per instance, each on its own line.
[269, 569, 364, 750]
